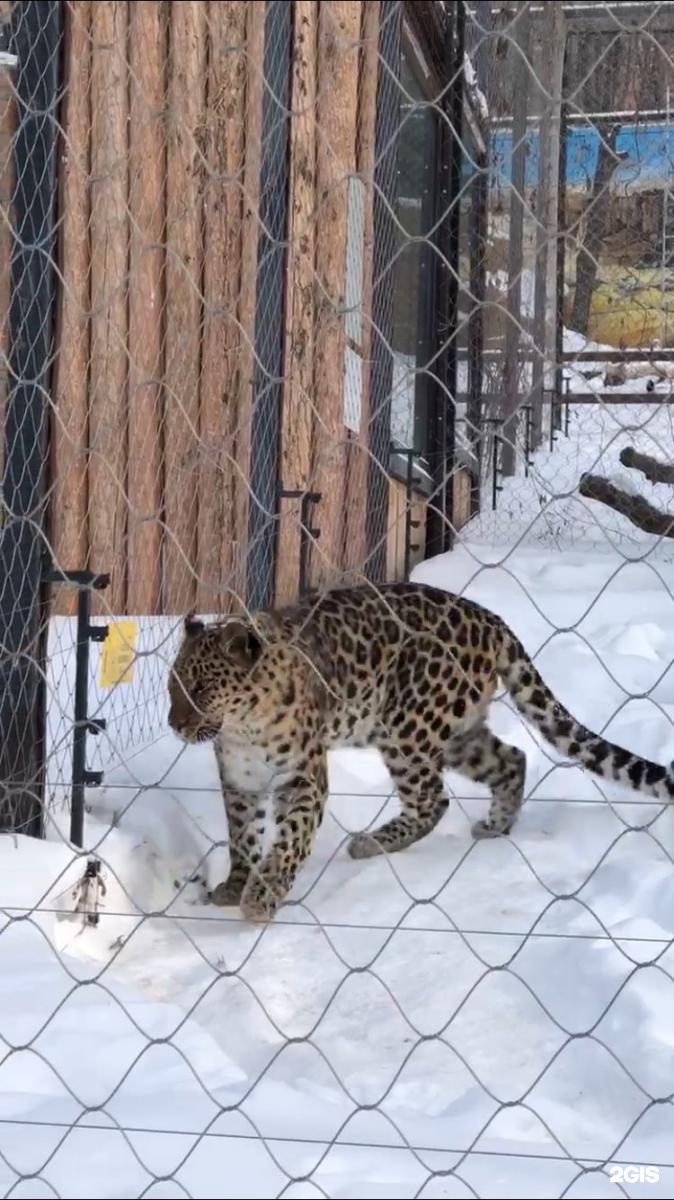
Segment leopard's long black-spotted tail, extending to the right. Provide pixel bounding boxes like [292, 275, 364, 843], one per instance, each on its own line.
[497, 624, 674, 800]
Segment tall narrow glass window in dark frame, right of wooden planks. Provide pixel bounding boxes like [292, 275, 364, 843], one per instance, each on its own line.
[391, 53, 437, 456]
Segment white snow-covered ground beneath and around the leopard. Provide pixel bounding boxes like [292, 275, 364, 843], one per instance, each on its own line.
[0, 544, 674, 1200]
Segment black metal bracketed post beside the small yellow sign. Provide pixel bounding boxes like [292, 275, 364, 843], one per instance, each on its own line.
[44, 568, 110, 850]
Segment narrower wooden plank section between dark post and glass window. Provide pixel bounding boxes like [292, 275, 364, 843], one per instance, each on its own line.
[277, 0, 379, 600]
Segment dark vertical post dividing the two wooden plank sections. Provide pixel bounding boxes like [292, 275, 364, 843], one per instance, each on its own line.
[247, 0, 295, 608]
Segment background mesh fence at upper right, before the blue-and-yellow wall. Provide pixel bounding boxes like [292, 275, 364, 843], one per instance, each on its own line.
[460, 5, 673, 560]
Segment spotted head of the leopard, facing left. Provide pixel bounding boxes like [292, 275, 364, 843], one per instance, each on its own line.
[168, 617, 264, 742]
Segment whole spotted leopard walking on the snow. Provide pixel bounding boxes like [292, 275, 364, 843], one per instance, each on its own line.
[168, 582, 674, 922]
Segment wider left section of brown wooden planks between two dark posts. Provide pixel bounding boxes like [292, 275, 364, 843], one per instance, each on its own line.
[49, 0, 264, 613]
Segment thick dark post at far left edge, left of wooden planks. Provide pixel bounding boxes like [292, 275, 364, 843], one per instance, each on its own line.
[0, 0, 62, 836]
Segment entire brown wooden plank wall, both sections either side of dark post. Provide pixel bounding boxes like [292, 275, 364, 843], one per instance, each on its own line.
[48, 0, 436, 614]
